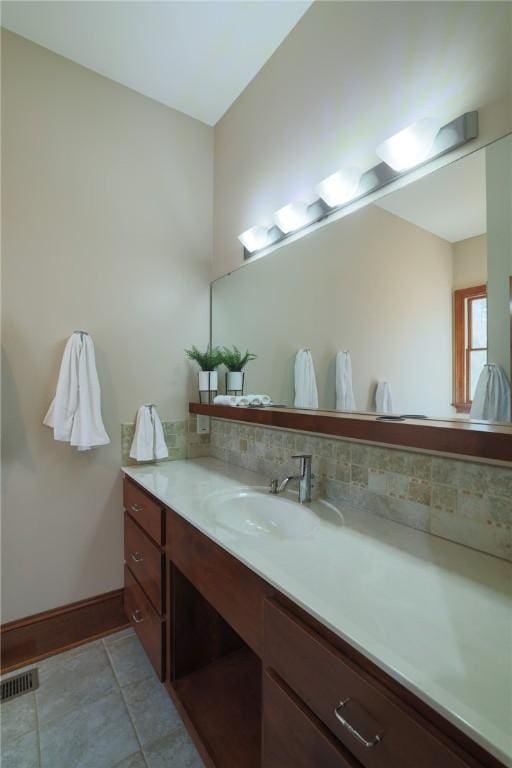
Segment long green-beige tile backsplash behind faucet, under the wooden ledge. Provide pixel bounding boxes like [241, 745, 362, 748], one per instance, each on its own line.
[210, 419, 512, 560]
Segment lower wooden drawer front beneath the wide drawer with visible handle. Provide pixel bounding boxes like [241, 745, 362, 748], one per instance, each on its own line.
[261, 672, 357, 768]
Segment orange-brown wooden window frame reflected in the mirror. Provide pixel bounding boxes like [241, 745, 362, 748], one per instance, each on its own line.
[452, 285, 487, 413]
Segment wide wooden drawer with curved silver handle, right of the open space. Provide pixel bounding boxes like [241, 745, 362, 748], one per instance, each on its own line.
[264, 601, 474, 768]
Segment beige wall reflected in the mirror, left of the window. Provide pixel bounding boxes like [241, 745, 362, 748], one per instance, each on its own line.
[213, 206, 453, 416]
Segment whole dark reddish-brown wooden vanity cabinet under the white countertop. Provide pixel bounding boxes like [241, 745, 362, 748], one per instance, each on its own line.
[125, 478, 504, 768]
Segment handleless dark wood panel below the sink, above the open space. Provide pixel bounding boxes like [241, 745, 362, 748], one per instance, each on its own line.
[167, 512, 274, 658]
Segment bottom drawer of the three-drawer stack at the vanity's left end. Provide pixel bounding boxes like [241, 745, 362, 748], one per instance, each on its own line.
[124, 566, 165, 680]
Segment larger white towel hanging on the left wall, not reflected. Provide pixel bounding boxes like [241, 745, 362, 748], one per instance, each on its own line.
[43, 332, 110, 451]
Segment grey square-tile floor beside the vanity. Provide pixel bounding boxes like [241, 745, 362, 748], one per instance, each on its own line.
[0, 629, 203, 768]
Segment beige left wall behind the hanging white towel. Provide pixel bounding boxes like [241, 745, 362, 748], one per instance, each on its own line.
[2, 33, 213, 621]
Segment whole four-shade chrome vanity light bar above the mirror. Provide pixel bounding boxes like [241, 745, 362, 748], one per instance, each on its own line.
[239, 111, 478, 259]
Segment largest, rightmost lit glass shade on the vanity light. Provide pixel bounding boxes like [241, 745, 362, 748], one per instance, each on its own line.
[376, 117, 441, 171]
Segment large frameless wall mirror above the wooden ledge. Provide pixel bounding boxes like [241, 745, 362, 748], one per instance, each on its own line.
[211, 135, 512, 420]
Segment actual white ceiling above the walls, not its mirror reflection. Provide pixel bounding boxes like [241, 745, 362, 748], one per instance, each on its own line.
[1, 0, 312, 125]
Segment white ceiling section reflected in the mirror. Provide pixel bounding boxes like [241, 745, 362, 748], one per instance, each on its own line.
[376, 150, 487, 243]
